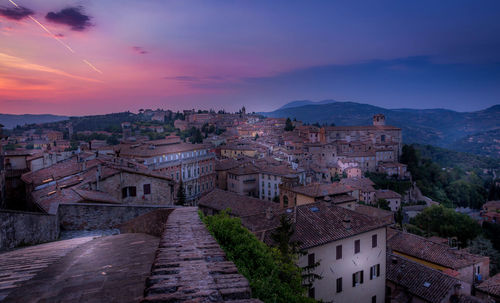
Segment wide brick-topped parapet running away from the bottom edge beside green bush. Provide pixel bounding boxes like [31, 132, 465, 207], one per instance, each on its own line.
[142, 207, 261, 303]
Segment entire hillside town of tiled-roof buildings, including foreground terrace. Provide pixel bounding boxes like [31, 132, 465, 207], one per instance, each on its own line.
[0, 107, 500, 303]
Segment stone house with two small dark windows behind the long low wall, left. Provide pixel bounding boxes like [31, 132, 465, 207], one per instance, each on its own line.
[21, 156, 174, 214]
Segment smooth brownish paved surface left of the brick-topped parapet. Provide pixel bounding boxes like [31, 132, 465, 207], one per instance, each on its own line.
[0, 234, 159, 303]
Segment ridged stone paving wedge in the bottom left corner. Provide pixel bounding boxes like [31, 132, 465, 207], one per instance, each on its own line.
[0, 237, 93, 301]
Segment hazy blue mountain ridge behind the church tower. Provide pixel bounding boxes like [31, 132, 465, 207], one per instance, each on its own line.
[261, 102, 500, 158]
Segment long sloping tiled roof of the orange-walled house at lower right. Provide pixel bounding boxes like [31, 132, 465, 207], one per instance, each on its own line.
[387, 229, 488, 270]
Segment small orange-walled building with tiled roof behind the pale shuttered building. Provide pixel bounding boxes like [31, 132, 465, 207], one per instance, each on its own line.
[279, 182, 358, 209]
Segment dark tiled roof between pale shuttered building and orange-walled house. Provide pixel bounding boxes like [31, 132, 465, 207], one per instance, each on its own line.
[386, 253, 461, 303]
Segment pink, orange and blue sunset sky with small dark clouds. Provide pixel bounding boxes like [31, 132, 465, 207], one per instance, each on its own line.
[0, 0, 500, 115]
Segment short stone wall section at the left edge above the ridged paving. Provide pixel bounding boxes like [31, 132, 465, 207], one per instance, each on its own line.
[0, 210, 59, 250]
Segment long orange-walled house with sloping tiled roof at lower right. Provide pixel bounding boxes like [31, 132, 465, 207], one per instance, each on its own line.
[387, 228, 490, 285]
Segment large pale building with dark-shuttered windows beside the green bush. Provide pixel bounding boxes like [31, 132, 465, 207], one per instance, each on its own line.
[241, 202, 387, 302]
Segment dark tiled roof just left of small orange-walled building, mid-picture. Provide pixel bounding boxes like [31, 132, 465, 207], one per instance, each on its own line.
[198, 188, 279, 217]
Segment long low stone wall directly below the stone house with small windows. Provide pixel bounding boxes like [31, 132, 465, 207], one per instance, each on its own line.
[58, 203, 169, 230]
